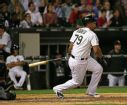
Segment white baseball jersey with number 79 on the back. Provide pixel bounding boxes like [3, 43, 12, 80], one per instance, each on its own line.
[70, 28, 99, 58]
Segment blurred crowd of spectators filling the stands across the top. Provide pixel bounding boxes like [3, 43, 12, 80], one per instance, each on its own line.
[0, 0, 127, 28]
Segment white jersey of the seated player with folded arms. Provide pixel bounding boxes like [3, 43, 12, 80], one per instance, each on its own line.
[6, 55, 24, 70]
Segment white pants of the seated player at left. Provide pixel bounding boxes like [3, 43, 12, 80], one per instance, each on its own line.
[8, 69, 26, 87]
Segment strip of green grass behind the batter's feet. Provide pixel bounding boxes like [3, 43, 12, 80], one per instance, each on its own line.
[16, 87, 127, 94]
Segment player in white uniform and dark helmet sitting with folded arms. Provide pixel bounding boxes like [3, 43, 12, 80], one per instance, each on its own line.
[6, 45, 26, 89]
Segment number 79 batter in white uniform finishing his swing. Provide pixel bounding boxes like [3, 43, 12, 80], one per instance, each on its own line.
[53, 15, 104, 99]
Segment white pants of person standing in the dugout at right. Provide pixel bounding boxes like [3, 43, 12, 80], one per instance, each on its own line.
[107, 74, 125, 87]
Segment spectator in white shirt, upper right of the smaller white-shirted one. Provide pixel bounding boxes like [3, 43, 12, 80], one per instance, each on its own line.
[26, 2, 43, 26]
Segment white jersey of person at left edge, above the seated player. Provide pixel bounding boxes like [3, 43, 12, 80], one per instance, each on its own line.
[0, 32, 11, 53]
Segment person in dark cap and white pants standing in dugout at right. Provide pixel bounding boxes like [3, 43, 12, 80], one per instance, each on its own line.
[107, 40, 126, 87]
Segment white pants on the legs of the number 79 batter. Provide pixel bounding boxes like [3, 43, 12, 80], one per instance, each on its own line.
[53, 57, 103, 95]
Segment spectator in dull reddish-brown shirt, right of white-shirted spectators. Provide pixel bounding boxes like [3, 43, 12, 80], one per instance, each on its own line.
[43, 4, 58, 26]
